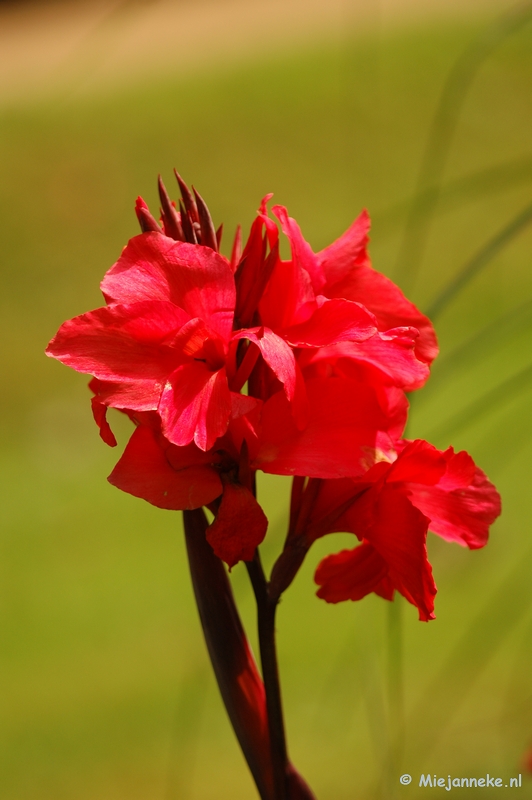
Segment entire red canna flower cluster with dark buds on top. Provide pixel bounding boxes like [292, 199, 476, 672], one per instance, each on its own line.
[47, 176, 500, 620]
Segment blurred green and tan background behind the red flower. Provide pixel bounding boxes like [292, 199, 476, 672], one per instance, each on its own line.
[0, 0, 532, 800]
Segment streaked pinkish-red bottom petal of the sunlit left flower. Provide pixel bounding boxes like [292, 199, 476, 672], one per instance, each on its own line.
[158, 362, 231, 450]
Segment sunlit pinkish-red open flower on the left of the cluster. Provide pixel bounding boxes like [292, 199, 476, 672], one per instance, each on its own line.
[47, 233, 239, 450]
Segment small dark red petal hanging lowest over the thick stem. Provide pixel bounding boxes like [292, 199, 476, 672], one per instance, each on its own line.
[207, 482, 268, 567]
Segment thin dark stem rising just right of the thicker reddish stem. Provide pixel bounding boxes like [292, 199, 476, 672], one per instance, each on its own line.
[246, 550, 288, 800]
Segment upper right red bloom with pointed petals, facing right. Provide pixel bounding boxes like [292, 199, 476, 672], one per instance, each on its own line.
[259, 206, 438, 391]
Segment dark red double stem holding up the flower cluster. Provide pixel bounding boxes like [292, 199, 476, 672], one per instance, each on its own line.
[183, 510, 316, 800]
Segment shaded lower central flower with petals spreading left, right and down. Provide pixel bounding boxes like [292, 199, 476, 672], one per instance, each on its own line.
[105, 366, 406, 567]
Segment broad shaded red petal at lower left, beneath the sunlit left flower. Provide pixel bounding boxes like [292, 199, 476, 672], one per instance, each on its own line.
[108, 427, 222, 510]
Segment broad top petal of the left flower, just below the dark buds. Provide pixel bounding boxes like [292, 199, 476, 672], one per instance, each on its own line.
[101, 233, 235, 339]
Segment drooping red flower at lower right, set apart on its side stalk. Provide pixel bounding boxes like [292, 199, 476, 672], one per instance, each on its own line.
[272, 440, 500, 620]
